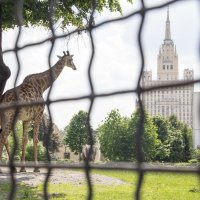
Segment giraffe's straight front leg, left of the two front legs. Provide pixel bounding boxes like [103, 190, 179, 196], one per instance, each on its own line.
[20, 121, 30, 172]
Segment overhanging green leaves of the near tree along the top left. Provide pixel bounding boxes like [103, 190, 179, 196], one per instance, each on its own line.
[0, 0, 132, 29]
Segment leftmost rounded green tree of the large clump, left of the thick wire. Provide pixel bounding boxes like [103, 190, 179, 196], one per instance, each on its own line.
[97, 110, 134, 161]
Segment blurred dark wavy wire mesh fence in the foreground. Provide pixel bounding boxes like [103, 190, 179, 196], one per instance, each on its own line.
[0, 0, 200, 200]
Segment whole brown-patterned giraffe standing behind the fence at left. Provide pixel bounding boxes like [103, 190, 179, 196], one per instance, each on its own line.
[0, 52, 76, 172]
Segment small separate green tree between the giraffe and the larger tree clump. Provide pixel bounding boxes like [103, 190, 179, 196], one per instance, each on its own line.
[64, 110, 95, 157]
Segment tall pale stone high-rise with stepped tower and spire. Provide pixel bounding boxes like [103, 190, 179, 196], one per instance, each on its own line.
[142, 10, 194, 128]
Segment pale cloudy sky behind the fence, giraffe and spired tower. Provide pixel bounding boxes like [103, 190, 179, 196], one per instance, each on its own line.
[3, 0, 200, 129]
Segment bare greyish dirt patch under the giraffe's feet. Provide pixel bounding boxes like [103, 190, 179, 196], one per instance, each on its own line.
[0, 168, 125, 186]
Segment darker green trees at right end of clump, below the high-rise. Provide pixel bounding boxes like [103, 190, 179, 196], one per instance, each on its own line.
[153, 115, 192, 162]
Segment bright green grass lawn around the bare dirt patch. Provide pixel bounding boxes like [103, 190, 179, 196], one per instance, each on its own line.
[0, 170, 200, 200]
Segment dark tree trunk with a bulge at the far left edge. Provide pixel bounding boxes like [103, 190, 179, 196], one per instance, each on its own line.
[0, 4, 11, 99]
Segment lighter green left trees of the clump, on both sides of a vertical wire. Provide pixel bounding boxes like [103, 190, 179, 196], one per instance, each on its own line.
[98, 110, 159, 161]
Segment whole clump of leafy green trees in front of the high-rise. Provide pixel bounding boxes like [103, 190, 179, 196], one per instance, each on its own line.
[98, 109, 192, 162]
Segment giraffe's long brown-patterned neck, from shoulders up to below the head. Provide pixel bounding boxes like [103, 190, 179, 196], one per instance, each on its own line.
[23, 59, 65, 94]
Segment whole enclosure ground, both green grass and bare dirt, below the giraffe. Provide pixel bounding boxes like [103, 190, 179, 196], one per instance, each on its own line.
[0, 169, 200, 200]
